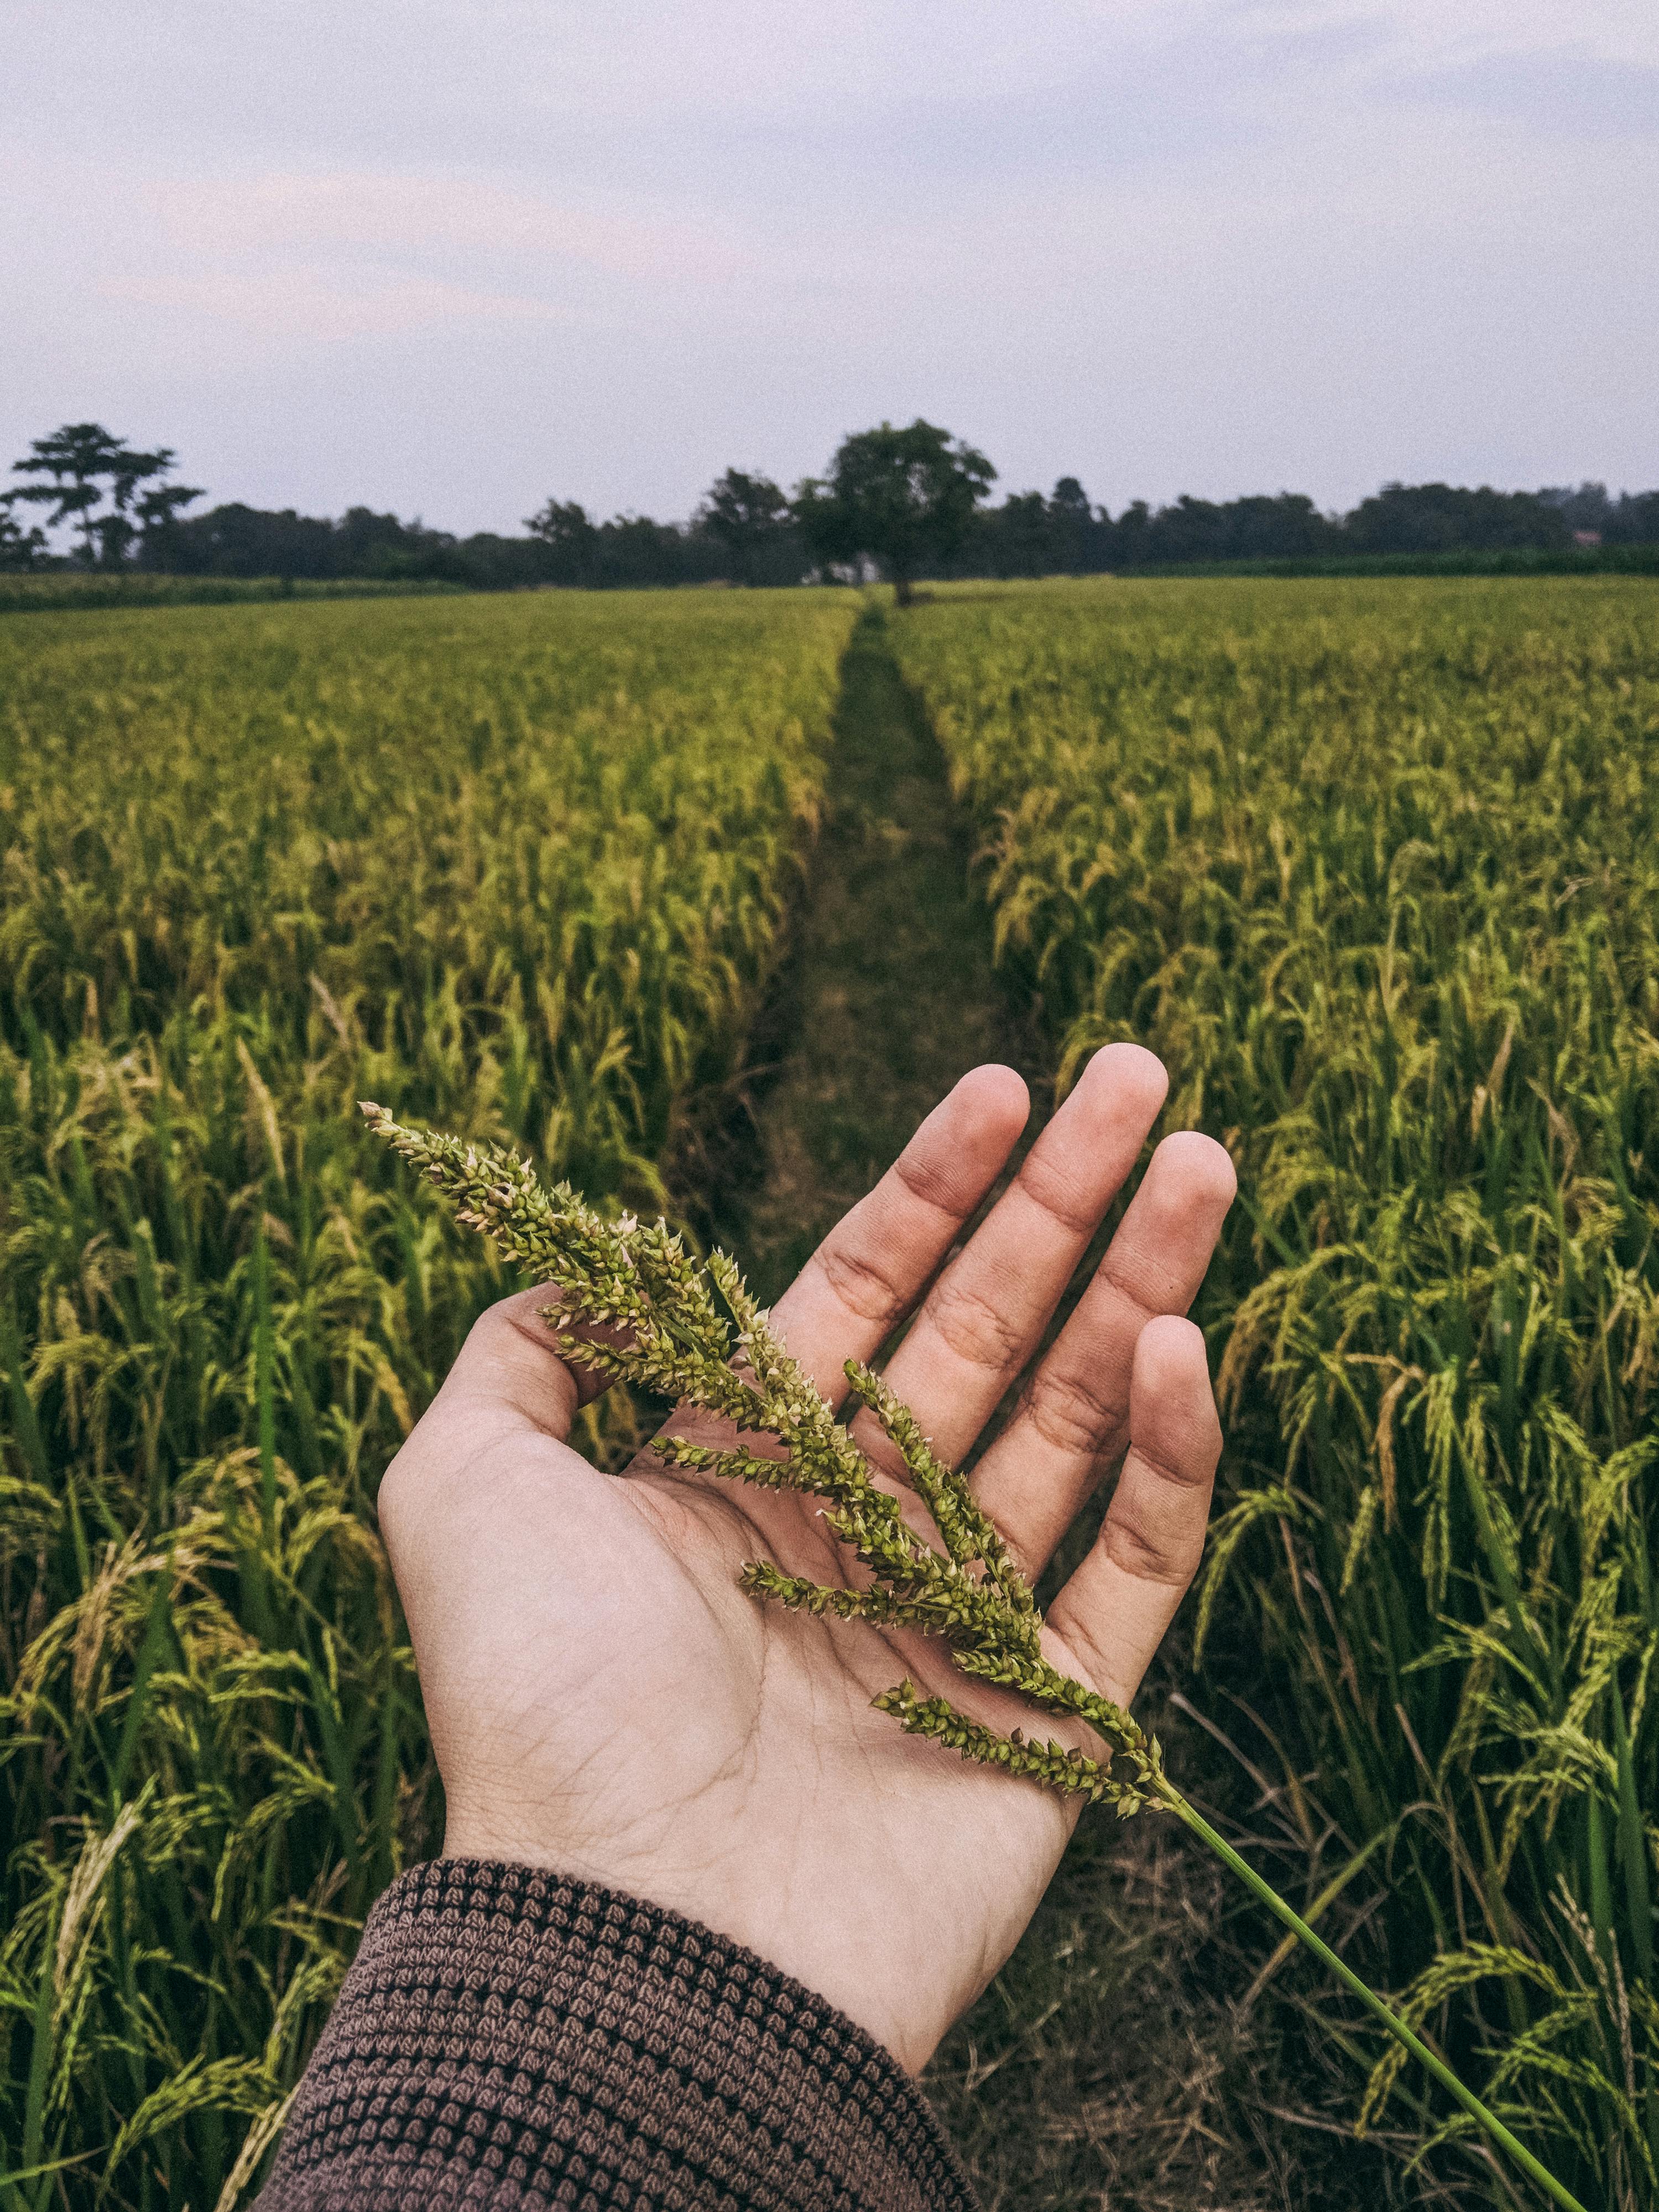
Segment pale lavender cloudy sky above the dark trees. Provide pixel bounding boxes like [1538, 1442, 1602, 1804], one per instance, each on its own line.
[0, 0, 1659, 531]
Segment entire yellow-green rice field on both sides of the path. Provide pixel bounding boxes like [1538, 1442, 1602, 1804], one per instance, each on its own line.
[0, 577, 1659, 2212]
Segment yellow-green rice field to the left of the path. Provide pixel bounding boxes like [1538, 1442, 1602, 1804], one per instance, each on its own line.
[0, 593, 856, 2212]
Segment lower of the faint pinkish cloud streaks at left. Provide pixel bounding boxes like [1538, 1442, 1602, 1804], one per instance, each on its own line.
[102, 268, 560, 341]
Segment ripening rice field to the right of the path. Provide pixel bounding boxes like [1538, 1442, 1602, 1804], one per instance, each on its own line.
[894, 580, 1659, 2208]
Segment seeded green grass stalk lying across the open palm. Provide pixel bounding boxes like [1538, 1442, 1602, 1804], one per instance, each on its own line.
[363, 1104, 1586, 2212]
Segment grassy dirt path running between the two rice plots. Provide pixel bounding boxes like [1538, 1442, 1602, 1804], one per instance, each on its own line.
[699, 608, 1407, 2212]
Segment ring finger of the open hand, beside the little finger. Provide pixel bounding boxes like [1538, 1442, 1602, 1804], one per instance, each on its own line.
[973, 1130, 1239, 1579]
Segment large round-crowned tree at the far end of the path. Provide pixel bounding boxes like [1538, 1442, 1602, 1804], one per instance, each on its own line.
[794, 416, 995, 606]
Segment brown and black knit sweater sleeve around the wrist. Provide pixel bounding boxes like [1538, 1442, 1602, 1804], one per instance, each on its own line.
[257, 1858, 973, 2212]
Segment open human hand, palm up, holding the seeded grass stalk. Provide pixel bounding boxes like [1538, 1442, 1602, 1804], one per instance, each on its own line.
[380, 1044, 1234, 2070]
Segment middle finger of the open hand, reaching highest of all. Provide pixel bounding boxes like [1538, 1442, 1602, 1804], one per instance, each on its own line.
[854, 1044, 1168, 1469]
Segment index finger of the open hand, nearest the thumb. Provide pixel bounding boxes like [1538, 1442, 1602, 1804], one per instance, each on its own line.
[772, 1066, 1031, 1405]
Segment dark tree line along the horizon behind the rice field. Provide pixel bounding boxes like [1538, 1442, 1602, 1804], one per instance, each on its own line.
[0, 420, 1659, 595]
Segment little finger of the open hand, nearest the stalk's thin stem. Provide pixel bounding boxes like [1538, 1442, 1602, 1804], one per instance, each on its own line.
[1048, 1314, 1221, 1705]
